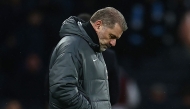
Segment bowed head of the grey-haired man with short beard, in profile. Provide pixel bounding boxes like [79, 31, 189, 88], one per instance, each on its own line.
[90, 7, 128, 51]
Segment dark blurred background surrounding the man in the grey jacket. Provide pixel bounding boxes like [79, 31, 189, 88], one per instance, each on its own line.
[0, 0, 190, 109]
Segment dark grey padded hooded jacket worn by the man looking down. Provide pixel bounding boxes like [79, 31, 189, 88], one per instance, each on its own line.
[49, 16, 111, 109]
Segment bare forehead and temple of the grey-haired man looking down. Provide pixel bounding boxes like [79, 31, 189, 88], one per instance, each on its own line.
[108, 23, 123, 38]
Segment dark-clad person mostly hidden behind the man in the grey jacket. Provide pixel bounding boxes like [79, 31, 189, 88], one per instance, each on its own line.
[77, 13, 120, 106]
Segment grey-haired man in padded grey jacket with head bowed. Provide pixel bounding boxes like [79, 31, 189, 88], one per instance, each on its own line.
[49, 7, 127, 109]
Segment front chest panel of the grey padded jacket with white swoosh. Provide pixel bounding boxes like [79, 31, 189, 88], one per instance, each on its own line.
[83, 54, 109, 101]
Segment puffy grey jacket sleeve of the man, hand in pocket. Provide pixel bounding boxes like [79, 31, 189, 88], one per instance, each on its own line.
[49, 52, 91, 109]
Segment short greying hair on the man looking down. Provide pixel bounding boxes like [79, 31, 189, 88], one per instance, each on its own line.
[90, 7, 128, 31]
